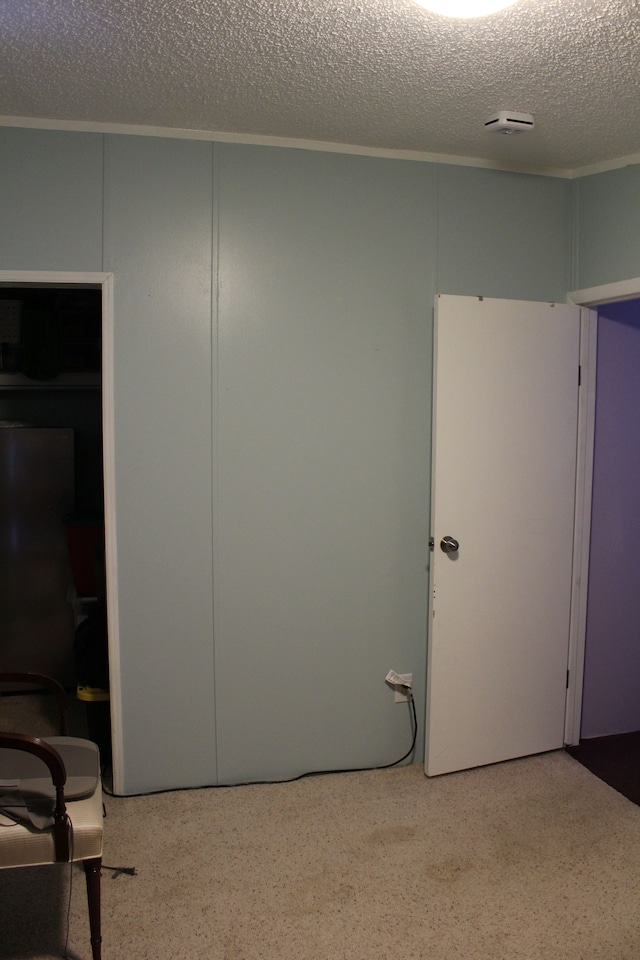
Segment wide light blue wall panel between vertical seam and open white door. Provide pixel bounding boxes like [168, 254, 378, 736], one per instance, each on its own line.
[215, 146, 435, 781]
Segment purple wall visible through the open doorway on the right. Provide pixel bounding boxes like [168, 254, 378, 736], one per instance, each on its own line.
[581, 300, 640, 738]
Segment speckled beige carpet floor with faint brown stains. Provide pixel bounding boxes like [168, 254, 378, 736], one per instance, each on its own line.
[0, 700, 640, 960]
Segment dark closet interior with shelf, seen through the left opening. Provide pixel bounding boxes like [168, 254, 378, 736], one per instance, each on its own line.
[0, 285, 104, 690]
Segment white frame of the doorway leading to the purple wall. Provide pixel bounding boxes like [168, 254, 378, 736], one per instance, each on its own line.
[565, 277, 640, 744]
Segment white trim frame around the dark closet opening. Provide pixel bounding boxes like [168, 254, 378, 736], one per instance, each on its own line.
[0, 270, 124, 793]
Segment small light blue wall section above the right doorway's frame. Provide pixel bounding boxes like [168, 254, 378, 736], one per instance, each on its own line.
[572, 164, 640, 290]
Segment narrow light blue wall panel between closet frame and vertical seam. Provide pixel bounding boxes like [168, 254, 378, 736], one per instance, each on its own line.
[104, 136, 216, 792]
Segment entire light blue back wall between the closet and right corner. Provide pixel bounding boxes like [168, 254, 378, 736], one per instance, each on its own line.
[0, 128, 571, 793]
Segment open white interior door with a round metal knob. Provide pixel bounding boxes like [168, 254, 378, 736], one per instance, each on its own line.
[425, 296, 580, 776]
